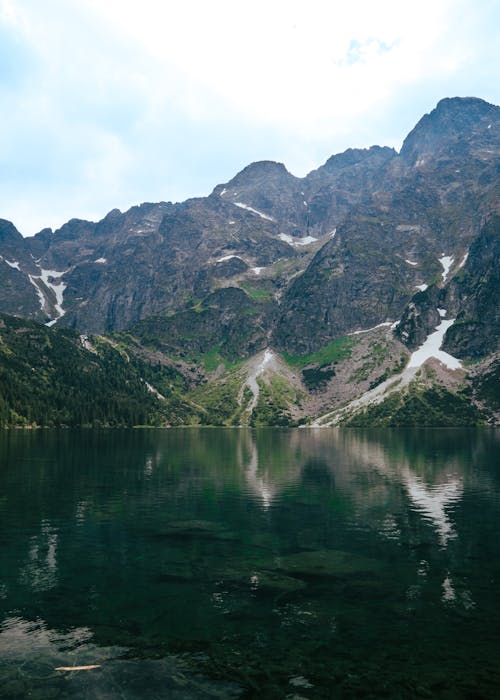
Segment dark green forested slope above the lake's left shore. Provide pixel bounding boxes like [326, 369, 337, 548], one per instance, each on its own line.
[0, 315, 197, 427]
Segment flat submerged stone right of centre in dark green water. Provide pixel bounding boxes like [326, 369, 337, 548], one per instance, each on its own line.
[277, 549, 380, 578]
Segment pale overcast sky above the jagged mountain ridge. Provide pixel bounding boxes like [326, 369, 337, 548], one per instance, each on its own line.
[0, 0, 500, 235]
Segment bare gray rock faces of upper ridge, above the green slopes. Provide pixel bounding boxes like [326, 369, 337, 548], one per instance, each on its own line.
[0, 98, 500, 364]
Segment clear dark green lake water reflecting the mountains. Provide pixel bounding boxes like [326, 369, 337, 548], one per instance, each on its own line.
[0, 429, 500, 700]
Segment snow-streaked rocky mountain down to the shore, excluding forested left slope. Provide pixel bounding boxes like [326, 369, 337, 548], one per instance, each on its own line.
[0, 98, 500, 424]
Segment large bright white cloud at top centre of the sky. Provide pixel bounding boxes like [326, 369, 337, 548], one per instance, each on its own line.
[80, 0, 457, 132]
